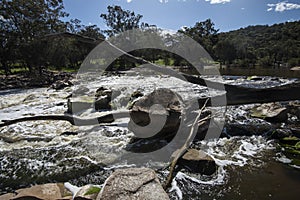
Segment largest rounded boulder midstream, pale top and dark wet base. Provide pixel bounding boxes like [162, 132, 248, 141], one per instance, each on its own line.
[128, 89, 182, 138]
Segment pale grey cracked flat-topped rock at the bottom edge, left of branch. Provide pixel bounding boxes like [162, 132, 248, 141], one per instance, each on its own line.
[97, 168, 169, 200]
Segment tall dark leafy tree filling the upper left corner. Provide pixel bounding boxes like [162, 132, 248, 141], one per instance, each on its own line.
[0, 0, 68, 72]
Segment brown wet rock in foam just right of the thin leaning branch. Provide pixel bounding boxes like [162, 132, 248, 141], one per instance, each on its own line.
[178, 149, 217, 175]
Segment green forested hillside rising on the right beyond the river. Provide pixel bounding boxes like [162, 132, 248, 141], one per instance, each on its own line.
[215, 21, 300, 67]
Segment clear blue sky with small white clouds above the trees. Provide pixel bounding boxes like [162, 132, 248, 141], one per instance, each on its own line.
[64, 0, 300, 32]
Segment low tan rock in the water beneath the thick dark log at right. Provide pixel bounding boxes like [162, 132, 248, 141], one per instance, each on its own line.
[251, 103, 288, 122]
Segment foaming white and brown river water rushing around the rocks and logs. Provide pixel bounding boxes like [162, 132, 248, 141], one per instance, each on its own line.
[0, 71, 300, 199]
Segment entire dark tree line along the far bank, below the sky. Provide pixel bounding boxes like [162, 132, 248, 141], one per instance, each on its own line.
[0, 0, 300, 74]
